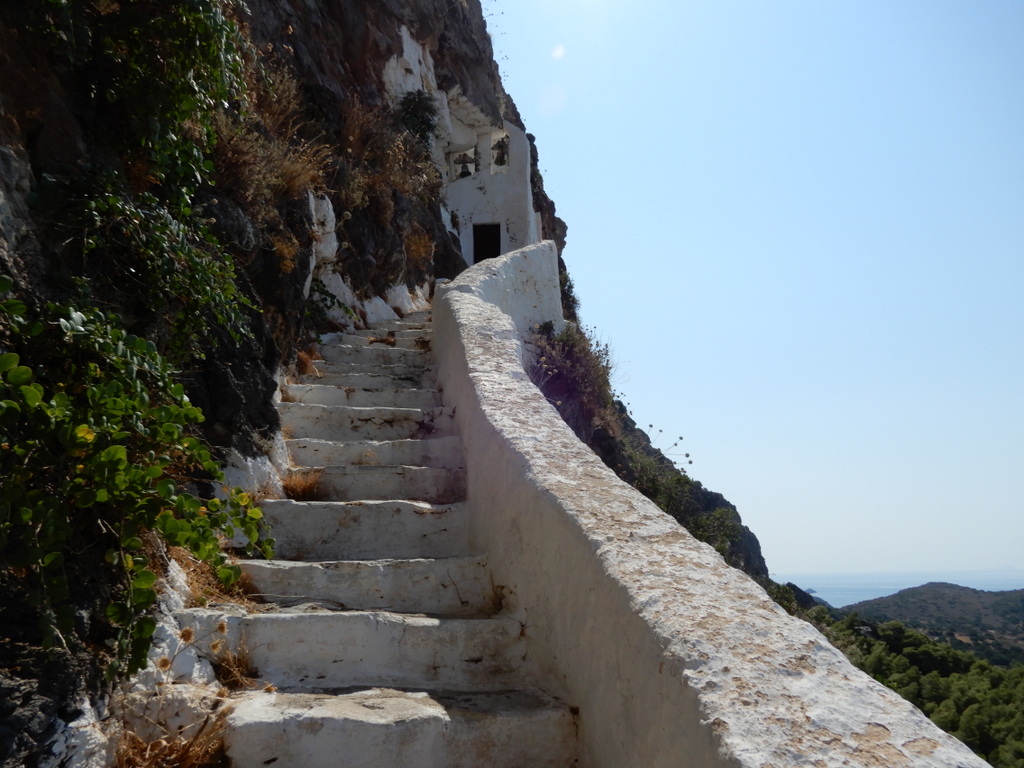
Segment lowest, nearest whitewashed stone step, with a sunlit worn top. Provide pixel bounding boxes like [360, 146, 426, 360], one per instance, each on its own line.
[225, 688, 577, 768]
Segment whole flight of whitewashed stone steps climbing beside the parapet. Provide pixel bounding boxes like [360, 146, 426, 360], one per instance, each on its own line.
[179, 313, 577, 768]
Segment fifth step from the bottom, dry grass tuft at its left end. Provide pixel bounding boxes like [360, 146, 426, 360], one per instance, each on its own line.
[292, 465, 466, 504]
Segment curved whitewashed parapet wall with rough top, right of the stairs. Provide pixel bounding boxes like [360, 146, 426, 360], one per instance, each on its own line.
[434, 243, 987, 768]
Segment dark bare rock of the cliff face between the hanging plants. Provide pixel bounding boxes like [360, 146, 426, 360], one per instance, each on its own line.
[0, 0, 564, 454]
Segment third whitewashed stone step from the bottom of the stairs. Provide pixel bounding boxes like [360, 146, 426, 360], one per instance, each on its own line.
[241, 557, 493, 617]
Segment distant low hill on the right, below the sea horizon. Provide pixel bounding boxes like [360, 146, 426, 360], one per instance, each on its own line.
[842, 582, 1024, 666]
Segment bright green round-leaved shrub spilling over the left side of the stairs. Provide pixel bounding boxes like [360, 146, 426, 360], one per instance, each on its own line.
[0, 276, 273, 674]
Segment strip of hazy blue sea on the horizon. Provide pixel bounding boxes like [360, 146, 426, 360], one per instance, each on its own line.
[771, 570, 1024, 608]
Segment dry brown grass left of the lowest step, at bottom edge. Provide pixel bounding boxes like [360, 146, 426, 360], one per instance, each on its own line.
[115, 706, 230, 768]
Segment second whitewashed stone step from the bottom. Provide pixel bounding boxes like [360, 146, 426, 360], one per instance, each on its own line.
[175, 605, 525, 691]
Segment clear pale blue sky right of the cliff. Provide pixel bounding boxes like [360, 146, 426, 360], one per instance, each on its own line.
[484, 0, 1024, 587]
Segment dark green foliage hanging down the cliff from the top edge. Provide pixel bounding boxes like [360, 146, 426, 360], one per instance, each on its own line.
[23, 0, 260, 364]
